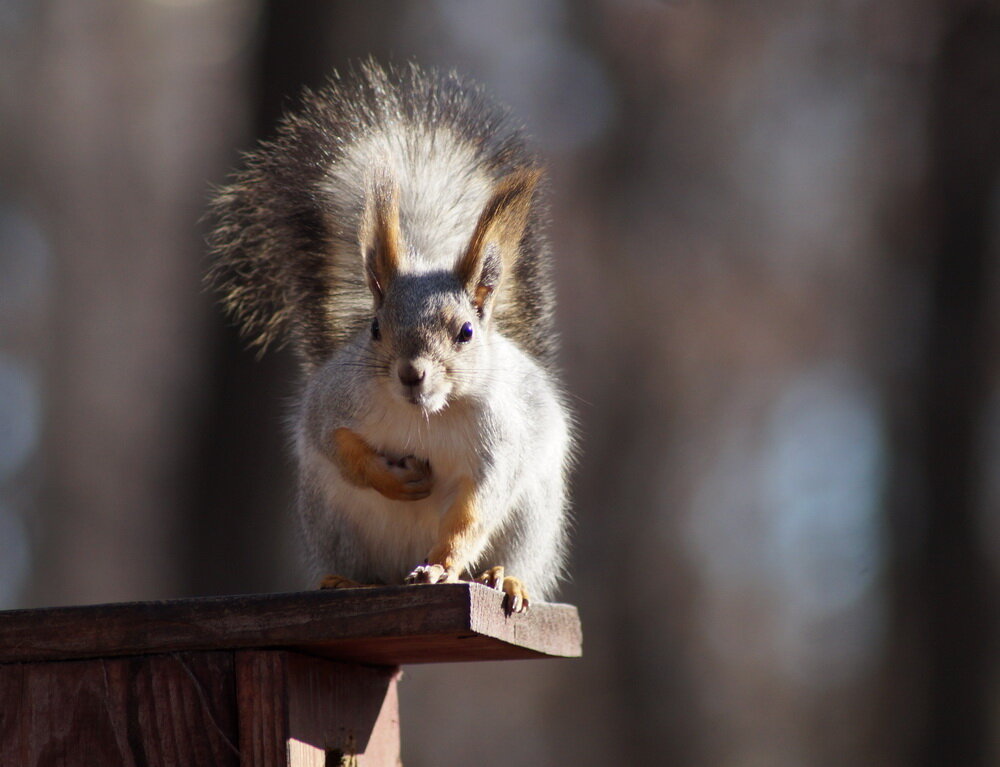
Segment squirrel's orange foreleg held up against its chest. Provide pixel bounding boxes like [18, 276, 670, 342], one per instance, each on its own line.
[333, 428, 434, 501]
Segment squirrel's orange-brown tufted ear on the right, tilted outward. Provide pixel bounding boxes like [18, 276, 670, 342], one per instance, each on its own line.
[455, 168, 542, 316]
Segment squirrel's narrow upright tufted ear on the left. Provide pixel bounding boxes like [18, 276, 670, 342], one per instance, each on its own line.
[358, 171, 400, 306]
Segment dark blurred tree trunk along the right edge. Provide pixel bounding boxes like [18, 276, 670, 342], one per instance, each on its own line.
[886, 2, 1000, 767]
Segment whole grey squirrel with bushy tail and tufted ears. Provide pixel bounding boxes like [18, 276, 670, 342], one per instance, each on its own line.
[207, 60, 574, 612]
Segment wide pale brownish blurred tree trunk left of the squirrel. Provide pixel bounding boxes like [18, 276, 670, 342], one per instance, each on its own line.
[18, 0, 254, 605]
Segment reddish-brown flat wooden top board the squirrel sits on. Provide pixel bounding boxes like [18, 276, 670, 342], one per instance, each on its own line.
[0, 583, 581, 666]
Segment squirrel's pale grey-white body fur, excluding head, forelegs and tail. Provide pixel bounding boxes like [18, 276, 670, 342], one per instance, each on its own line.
[298, 328, 570, 598]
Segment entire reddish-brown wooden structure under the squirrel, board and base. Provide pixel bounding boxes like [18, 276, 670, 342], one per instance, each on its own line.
[0, 583, 581, 767]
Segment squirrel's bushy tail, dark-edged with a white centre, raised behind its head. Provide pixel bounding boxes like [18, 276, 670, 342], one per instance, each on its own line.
[208, 62, 556, 368]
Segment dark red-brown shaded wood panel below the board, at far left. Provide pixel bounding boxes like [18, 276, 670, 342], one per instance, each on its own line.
[0, 652, 240, 767]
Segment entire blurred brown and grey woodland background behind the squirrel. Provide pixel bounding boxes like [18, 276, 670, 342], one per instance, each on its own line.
[0, 0, 1000, 767]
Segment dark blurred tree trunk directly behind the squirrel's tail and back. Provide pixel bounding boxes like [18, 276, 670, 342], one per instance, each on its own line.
[184, 0, 410, 594]
